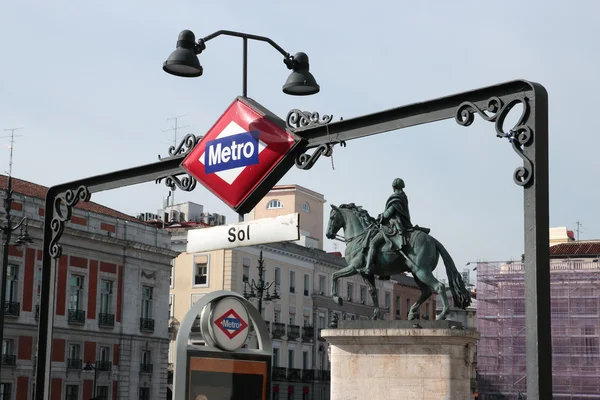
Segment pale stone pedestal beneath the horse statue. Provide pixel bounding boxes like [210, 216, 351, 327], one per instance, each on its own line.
[321, 321, 479, 400]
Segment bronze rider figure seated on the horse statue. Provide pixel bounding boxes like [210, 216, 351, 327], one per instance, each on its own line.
[365, 178, 413, 274]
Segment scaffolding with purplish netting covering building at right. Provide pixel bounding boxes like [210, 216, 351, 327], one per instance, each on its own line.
[477, 259, 600, 400]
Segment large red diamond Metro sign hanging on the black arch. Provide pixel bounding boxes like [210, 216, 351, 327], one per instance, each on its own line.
[181, 97, 299, 213]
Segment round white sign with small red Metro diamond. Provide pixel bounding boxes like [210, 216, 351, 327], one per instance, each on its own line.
[209, 297, 250, 351]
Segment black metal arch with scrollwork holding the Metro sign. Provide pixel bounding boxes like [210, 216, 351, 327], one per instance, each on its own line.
[35, 81, 552, 400]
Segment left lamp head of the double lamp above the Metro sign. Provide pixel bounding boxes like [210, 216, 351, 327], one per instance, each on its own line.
[163, 30, 204, 78]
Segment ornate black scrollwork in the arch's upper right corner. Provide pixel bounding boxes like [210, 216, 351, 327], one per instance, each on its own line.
[455, 97, 533, 186]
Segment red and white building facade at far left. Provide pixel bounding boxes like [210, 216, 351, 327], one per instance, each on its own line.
[0, 176, 176, 400]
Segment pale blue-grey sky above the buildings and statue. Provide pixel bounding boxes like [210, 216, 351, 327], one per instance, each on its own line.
[0, 0, 600, 282]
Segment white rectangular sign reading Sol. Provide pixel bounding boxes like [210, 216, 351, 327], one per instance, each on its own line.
[186, 213, 300, 253]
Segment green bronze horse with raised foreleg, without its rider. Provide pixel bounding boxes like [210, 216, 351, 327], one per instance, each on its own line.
[326, 204, 471, 320]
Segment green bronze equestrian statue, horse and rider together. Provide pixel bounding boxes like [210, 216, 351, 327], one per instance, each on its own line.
[326, 178, 471, 320]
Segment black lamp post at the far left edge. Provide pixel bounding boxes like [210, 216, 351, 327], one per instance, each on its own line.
[0, 175, 33, 373]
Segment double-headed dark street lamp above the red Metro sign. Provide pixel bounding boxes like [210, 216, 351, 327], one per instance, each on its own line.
[163, 30, 320, 97]
